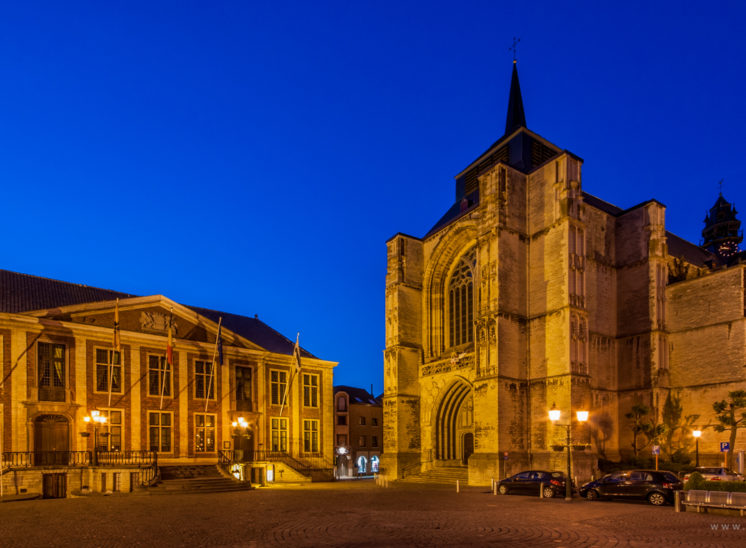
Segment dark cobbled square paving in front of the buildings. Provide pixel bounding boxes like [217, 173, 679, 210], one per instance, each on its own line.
[0, 481, 746, 547]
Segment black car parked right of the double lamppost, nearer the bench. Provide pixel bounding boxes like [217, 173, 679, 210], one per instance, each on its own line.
[580, 470, 683, 506]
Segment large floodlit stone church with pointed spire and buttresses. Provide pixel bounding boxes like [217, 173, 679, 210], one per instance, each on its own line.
[381, 64, 746, 484]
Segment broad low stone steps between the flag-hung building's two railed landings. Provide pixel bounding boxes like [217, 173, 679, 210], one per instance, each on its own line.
[147, 465, 251, 495]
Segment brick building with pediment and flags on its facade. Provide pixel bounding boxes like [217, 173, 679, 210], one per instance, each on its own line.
[0, 270, 336, 496]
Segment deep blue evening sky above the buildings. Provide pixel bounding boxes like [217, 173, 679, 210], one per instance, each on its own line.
[0, 1, 746, 393]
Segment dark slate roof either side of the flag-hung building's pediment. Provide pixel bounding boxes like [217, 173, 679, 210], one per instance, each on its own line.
[0, 270, 316, 358]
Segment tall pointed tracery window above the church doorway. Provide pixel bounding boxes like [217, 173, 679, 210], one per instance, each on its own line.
[448, 249, 476, 346]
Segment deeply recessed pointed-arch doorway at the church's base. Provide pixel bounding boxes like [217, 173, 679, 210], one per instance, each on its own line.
[435, 380, 473, 461]
